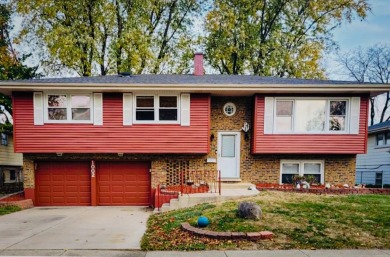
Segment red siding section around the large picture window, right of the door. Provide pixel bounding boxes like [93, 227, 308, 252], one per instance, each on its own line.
[252, 96, 368, 154]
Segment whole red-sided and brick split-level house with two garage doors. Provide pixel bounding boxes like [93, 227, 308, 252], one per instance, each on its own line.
[0, 54, 390, 206]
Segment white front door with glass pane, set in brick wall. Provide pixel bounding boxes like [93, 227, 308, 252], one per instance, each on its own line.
[217, 132, 241, 179]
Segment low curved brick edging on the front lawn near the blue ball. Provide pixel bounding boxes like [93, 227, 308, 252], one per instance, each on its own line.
[181, 222, 274, 241]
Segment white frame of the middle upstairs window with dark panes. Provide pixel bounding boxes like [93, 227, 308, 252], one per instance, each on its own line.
[133, 93, 181, 124]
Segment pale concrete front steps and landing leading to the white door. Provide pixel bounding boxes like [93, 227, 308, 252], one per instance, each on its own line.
[154, 183, 259, 212]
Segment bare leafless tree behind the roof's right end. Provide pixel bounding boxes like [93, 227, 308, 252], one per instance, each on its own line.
[338, 44, 390, 125]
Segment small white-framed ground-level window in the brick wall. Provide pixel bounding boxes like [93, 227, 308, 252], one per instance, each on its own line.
[280, 160, 324, 184]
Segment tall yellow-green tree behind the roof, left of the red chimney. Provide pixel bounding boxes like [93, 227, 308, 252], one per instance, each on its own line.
[15, 0, 204, 76]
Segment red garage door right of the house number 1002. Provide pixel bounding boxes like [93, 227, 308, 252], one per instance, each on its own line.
[96, 162, 150, 206]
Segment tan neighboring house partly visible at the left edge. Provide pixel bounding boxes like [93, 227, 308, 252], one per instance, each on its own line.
[0, 133, 23, 186]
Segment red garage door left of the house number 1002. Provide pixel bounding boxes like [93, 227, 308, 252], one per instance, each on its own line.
[35, 162, 91, 206]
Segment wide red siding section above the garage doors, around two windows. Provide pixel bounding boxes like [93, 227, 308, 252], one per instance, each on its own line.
[13, 93, 210, 154]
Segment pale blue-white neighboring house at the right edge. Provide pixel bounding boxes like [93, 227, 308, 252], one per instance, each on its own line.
[356, 121, 390, 186]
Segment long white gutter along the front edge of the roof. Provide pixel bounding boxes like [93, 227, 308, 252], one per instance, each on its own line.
[0, 81, 390, 96]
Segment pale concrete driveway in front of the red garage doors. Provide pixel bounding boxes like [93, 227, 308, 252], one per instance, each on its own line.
[0, 206, 152, 250]
